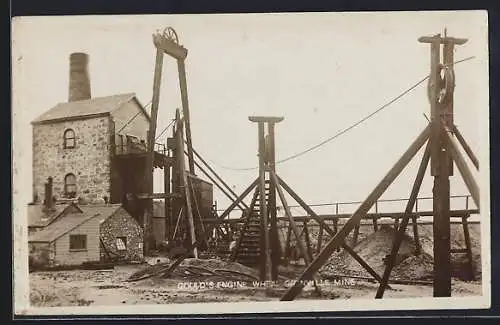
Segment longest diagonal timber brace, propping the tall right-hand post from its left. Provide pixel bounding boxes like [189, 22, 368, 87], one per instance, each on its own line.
[281, 126, 430, 301]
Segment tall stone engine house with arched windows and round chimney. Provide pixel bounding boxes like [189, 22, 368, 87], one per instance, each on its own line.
[32, 53, 149, 204]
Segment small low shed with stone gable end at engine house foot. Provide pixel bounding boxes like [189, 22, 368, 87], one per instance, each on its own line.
[29, 204, 143, 266]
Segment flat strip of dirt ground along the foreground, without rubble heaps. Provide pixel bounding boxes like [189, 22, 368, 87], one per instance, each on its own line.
[30, 258, 481, 307]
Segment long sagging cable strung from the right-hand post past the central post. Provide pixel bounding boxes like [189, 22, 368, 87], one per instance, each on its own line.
[201, 56, 475, 171]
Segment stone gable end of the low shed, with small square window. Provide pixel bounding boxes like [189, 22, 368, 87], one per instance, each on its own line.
[100, 208, 144, 261]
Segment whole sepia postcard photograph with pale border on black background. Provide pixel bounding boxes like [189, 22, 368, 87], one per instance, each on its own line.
[12, 11, 491, 315]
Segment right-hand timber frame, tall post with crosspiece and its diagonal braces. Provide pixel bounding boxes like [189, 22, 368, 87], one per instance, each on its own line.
[281, 32, 480, 301]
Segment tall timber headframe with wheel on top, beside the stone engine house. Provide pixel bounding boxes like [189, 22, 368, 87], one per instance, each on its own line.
[136, 27, 252, 257]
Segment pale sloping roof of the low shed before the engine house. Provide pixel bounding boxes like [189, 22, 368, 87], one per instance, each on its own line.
[29, 204, 121, 243]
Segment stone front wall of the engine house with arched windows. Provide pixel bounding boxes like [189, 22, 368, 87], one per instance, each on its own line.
[33, 117, 111, 203]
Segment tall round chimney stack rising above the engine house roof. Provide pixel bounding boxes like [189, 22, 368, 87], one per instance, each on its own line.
[68, 53, 91, 102]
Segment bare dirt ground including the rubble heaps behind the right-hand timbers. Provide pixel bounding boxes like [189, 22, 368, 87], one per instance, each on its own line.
[29, 225, 482, 307]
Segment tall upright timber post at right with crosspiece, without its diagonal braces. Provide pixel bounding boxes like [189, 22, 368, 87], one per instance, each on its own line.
[418, 30, 467, 297]
